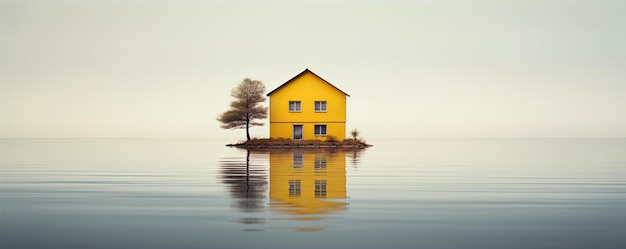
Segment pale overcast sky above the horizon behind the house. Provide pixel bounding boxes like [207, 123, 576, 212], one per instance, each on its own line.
[0, 0, 626, 139]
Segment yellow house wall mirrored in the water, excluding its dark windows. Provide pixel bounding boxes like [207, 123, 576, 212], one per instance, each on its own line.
[270, 150, 346, 214]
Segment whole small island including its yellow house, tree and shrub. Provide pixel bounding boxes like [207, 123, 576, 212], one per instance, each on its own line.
[217, 68, 371, 150]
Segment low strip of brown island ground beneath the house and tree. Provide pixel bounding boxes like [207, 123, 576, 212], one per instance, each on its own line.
[226, 138, 372, 149]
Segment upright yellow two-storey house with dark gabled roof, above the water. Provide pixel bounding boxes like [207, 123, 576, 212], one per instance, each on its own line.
[267, 69, 350, 140]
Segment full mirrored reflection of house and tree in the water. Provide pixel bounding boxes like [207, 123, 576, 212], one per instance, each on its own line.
[220, 149, 360, 231]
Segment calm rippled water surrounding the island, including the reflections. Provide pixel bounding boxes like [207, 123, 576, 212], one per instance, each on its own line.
[0, 139, 626, 249]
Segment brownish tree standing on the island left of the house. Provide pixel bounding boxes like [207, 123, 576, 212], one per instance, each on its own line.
[217, 78, 267, 140]
